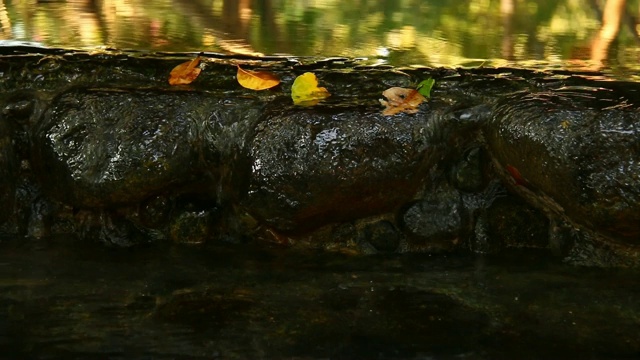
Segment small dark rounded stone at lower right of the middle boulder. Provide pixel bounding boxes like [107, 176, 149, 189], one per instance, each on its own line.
[400, 186, 465, 251]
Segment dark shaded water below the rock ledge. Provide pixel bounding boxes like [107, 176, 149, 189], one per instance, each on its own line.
[0, 240, 640, 359]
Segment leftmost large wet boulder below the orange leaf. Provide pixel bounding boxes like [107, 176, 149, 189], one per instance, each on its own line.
[33, 89, 218, 207]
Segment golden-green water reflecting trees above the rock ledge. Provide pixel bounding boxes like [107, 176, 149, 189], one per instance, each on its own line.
[0, 0, 638, 75]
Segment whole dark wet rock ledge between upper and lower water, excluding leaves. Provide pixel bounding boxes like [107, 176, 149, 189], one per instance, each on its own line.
[0, 52, 640, 266]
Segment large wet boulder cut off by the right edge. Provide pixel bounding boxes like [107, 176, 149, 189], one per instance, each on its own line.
[484, 87, 640, 244]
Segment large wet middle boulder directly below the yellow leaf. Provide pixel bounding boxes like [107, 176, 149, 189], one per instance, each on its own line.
[243, 101, 450, 232]
